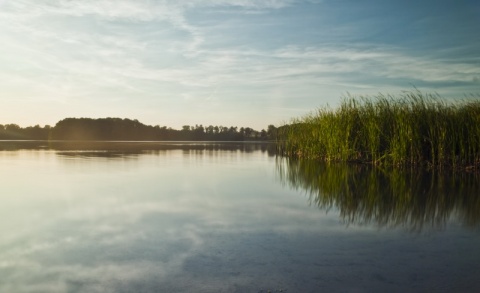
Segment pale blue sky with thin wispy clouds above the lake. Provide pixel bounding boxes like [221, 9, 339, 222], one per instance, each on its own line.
[0, 0, 480, 130]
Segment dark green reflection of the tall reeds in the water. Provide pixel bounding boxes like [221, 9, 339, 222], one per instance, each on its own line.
[277, 158, 480, 231]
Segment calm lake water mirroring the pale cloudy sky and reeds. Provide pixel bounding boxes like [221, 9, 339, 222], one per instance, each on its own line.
[0, 142, 480, 293]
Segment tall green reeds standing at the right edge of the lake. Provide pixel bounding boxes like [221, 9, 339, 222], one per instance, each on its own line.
[277, 91, 480, 169]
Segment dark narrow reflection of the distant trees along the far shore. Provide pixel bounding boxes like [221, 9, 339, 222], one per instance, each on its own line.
[0, 141, 275, 158]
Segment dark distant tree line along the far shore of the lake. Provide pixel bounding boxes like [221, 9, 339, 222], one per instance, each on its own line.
[0, 118, 277, 141]
